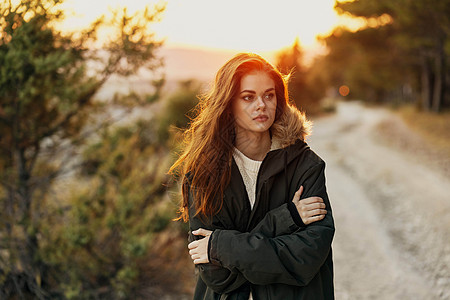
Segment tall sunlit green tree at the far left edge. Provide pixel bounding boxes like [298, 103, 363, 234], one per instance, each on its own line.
[0, 0, 163, 299]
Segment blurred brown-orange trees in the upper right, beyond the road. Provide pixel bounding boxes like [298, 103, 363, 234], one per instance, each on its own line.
[279, 0, 450, 112]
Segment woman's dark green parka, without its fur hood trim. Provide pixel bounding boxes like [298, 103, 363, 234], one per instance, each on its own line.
[187, 140, 334, 300]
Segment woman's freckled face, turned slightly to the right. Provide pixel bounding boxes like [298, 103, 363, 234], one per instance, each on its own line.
[231, 71, 277, 133]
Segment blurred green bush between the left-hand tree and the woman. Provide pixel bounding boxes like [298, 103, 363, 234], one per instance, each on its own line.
[40, 121, 175, 299]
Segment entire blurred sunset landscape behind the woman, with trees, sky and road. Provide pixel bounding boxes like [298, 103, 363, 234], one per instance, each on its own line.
[0, 0, 450, 299]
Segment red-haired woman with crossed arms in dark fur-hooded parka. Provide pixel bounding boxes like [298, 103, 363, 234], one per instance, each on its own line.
[171, 53, 334, 300]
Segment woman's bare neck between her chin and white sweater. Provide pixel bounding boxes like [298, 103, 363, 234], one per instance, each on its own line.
[236, 131, 272, 161]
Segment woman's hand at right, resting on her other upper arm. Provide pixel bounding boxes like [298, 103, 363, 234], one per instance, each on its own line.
[292, 186, 327, 225]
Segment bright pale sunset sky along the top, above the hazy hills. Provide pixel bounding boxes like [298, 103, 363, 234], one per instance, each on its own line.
[59, 0, 360, 52]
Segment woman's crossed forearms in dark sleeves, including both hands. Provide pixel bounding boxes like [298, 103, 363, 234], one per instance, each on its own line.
[184, 164, 334, 293]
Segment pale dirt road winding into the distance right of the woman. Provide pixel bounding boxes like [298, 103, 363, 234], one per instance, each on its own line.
[308, 102, 450, 300]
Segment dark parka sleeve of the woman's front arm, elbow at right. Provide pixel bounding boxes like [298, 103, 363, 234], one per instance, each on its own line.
[209, 162, 334, 286]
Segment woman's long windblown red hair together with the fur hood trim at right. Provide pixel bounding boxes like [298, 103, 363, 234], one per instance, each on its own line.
[169, 53, 311, 221]
